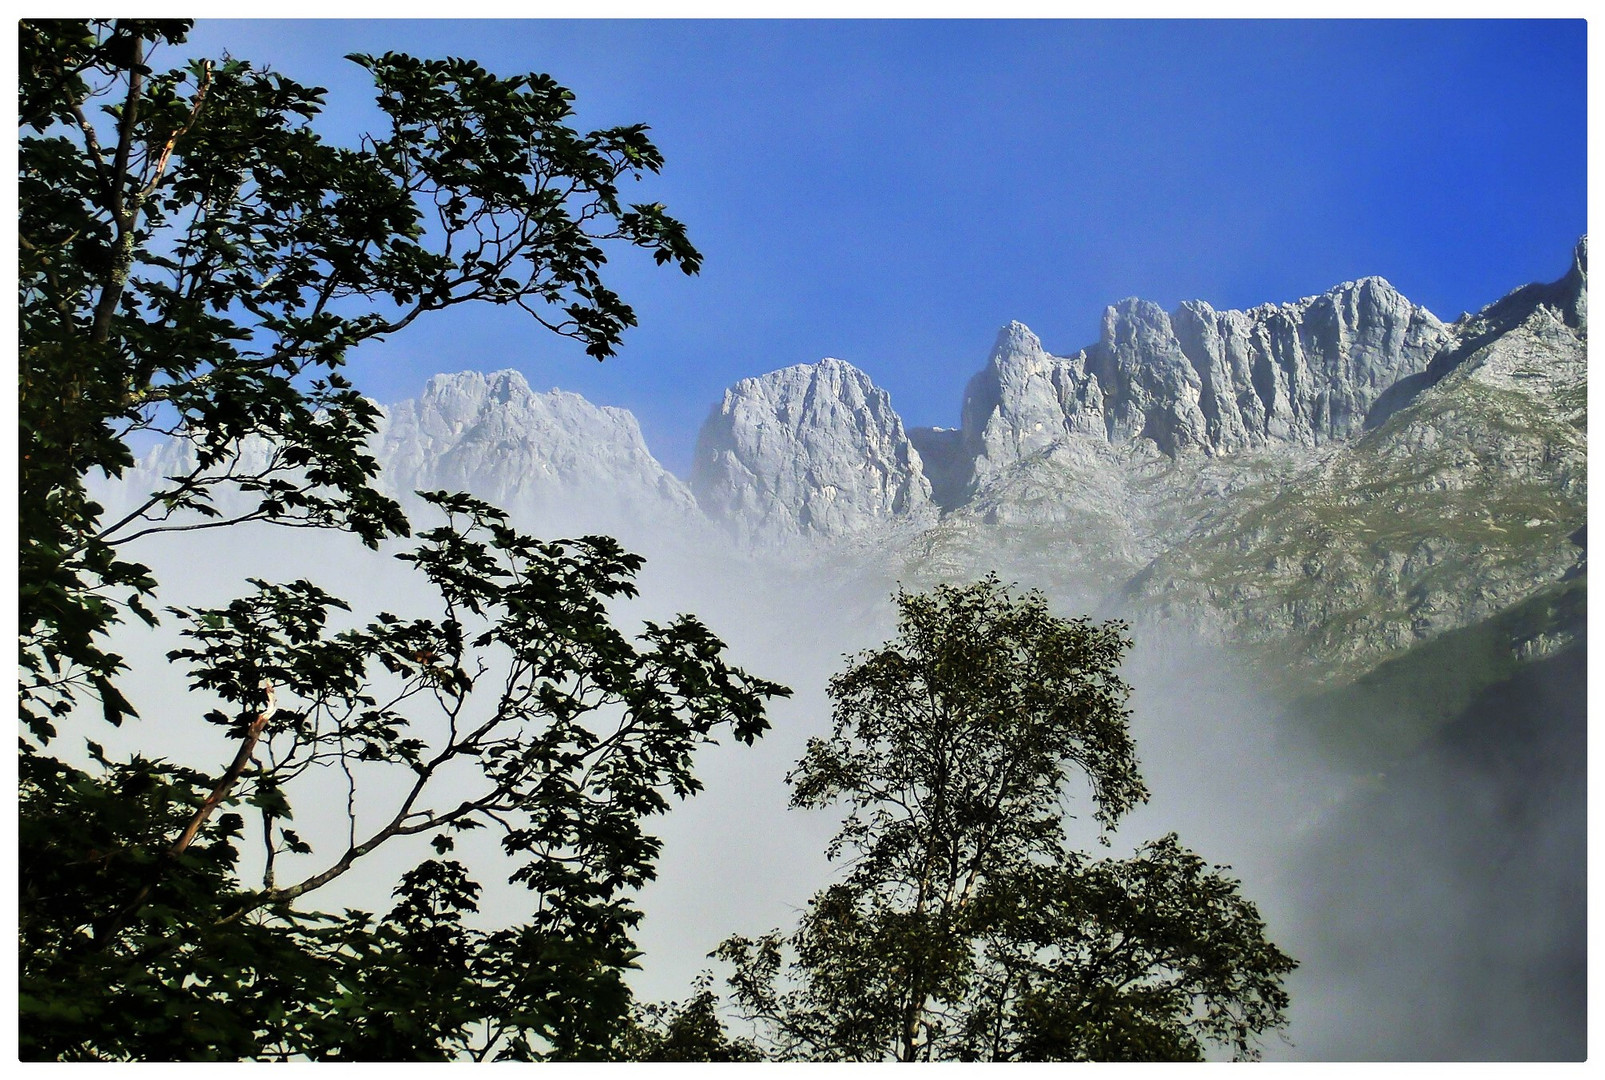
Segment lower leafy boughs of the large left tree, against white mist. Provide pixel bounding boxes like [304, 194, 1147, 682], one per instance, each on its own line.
[19, 493, 785, 1059]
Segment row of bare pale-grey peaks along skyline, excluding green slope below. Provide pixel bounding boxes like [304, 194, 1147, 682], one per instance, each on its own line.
[345, 238, 1587, 568]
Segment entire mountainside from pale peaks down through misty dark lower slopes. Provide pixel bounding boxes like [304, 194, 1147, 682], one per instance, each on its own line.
[104, 241, 1587, 1059]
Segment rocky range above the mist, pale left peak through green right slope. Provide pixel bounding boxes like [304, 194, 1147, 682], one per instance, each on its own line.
[113, 239, 1587, 744]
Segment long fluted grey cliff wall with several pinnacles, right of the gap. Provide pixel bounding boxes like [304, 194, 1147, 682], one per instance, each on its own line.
[963, 278, 1449, 486]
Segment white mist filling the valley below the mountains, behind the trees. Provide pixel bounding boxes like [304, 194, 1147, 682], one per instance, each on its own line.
[101, 478, 1586, 1061]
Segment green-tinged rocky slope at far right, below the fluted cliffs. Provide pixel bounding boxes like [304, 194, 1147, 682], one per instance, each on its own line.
[1110, 246, 1587, 676]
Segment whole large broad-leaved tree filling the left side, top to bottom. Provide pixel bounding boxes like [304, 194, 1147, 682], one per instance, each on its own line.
[18, 19, 785, 1059]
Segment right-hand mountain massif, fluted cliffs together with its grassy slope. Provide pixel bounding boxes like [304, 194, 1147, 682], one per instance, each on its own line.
[904, 244, 1587, 696]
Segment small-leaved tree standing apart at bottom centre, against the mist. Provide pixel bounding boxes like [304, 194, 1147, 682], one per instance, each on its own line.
[716, 576, 1295, 1061]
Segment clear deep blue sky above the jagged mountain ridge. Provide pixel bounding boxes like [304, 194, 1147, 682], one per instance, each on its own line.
[172, 19, 1587, 475]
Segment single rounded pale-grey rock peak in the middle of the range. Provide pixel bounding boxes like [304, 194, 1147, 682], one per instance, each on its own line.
[692, 359, 936, 539]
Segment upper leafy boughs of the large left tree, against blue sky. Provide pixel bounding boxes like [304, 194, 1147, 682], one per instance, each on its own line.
[18, 19, 701, 740]
